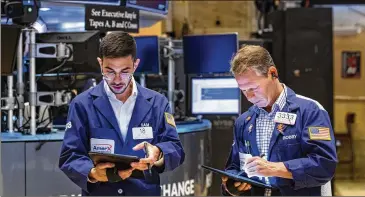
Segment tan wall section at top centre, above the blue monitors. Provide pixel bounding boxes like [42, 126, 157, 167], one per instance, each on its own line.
[172, 1, 257, 39]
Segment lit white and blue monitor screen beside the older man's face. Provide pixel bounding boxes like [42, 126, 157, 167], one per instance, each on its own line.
[191, 77, 240, 115]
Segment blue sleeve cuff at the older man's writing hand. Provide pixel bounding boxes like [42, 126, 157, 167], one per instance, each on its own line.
[283, 159, 307, 190]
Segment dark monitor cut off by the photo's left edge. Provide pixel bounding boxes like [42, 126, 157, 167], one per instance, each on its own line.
[1, 24, 21, 75]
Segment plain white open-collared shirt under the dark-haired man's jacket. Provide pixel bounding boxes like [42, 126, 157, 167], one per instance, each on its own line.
[104, 78, 138, 140]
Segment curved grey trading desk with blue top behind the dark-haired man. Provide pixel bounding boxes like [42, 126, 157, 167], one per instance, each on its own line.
[1, 120, 212, 196]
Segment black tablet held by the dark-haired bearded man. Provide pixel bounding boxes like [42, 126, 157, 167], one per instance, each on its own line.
[89, 152, 144, 178]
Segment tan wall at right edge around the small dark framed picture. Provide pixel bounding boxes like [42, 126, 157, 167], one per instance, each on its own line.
[334, 33, 365, 178]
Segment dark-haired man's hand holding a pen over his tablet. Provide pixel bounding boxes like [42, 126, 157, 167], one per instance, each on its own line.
[131, 142, 161, 170]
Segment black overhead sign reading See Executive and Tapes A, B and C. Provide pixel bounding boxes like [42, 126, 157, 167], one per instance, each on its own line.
[85, 5, 139, 33]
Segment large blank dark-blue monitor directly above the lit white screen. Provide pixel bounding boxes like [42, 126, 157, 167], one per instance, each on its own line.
[183, 33, 238, 74]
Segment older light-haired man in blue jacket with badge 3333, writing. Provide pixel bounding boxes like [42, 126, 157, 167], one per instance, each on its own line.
[222, 45, 337, 196]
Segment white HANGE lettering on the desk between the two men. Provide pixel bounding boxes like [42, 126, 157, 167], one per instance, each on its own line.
[161, 179, 195, 196]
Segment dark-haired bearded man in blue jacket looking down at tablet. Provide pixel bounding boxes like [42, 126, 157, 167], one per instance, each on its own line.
[59, 32, 185, 196]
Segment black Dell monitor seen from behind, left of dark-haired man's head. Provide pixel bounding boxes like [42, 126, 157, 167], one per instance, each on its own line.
[36, 31, 101, 74]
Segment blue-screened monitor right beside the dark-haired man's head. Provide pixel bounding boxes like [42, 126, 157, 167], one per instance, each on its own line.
[134, 36, 160, 74]
